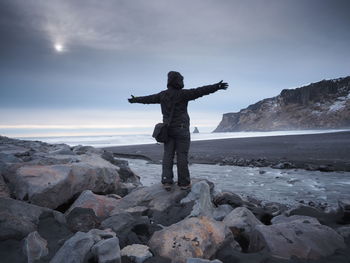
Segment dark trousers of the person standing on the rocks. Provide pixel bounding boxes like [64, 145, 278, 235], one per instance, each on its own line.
[162, 127, 191, 186]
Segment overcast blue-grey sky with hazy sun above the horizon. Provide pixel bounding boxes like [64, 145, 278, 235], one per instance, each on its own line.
[0, 0, 350, 134]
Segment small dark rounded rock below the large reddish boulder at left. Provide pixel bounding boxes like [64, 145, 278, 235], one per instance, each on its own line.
[66, 207, 100, 232]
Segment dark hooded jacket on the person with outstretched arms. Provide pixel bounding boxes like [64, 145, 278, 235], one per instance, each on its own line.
[132, 71, 220, 127]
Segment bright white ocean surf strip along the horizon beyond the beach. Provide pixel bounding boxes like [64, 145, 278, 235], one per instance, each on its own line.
[15, 129, 349, 147]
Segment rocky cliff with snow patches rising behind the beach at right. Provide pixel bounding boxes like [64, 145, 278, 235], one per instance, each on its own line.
[214, 76, 350, 132]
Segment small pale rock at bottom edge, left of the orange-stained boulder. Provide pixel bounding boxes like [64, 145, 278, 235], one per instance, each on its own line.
[121, 244, 153, 263]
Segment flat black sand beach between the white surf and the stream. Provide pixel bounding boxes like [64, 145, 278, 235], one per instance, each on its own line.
[105, 131, 350, 171]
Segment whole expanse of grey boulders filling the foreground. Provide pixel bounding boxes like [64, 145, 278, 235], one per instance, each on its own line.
[0, 137, 350, 263]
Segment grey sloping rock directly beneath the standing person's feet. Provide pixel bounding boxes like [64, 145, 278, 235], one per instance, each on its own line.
[111, 184, 193, 226]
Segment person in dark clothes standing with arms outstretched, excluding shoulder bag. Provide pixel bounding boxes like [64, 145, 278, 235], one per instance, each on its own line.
[128, 71, 228, 191]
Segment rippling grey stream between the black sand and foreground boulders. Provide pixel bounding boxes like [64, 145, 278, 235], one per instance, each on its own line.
[126, 159, 350, 207]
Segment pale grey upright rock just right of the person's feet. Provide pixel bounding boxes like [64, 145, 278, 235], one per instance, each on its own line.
[180, 181, 214, 217]
